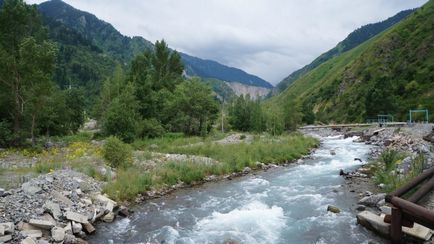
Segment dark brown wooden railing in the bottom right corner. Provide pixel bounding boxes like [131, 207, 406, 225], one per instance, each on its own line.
[384, 167, 434, 243]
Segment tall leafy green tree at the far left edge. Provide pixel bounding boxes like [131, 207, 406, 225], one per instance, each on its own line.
[0, 0, 56, 144]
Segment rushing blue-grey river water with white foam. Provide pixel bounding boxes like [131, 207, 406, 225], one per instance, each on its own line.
[90, 137, 381, 244]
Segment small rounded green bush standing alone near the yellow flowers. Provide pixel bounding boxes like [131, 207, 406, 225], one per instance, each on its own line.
[103, 136, 132, 168]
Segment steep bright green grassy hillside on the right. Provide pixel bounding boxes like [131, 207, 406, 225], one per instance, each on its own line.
[270, 1, 434, 122]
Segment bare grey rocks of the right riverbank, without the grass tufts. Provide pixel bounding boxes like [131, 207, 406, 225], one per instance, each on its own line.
[304, 124, 434, 243]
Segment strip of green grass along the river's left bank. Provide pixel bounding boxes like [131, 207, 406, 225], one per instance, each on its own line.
[104, 133, 318, 201]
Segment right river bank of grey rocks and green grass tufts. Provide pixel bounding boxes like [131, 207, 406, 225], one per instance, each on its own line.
[306, 124, 434, 243]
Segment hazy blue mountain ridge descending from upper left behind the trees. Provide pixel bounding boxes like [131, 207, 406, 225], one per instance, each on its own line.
[38, 0, 273, 88]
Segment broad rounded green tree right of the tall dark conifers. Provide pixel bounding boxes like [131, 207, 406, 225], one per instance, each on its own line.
[169, 78, 219, 136]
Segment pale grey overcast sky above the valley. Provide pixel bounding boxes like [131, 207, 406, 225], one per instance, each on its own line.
[27, 0, 427, 84]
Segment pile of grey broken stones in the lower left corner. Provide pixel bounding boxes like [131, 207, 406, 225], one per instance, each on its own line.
[0, 170, 128, 244]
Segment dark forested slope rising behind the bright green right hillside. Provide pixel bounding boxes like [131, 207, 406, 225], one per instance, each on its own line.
[276, 10, 414, 91]
